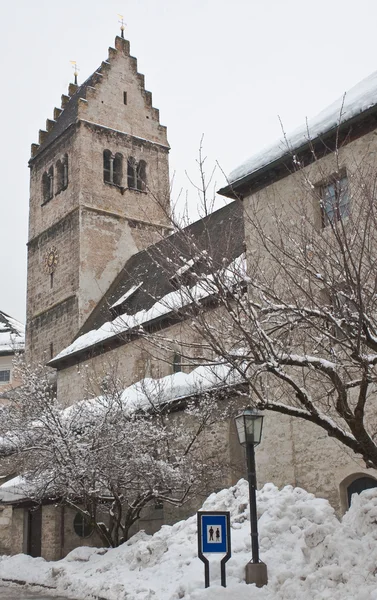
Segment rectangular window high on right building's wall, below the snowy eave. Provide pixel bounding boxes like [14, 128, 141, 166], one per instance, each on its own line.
[320, 172, 350, 227]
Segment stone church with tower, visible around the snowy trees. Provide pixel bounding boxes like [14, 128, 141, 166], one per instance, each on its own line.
[0, 31, 377, 560]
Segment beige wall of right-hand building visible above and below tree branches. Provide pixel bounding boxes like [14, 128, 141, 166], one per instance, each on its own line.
[244, 125, 377, 512]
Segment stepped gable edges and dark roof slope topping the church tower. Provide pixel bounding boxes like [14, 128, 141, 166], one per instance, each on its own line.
[30, 36, 165, 161]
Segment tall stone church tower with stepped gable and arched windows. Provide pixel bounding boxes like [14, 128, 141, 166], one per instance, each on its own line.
[26, 37, 169, 363]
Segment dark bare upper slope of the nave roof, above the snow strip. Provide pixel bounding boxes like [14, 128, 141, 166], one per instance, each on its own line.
[76, 201, 245, 337]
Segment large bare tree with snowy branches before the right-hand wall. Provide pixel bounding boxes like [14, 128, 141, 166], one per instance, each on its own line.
[137, 141, 377, 468]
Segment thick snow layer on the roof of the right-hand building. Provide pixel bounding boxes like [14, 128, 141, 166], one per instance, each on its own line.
[228, 71, 377, 185]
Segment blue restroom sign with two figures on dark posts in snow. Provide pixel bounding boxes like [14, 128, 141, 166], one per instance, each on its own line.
[198, 511, 231, 587]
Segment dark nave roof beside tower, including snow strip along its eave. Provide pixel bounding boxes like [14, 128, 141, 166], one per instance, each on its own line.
[49, 202, 244, 367]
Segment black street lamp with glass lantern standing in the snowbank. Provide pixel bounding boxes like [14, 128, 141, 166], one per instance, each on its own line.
[235, 407, 267, 587]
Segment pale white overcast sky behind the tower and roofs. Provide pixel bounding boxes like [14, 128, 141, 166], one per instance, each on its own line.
[0, 0, 377, 320]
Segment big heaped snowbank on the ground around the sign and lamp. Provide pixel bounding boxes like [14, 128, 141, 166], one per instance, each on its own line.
[0, 480, 377, 600]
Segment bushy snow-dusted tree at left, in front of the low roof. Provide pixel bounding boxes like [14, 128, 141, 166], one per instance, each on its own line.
[0, 358, 228, 547]
